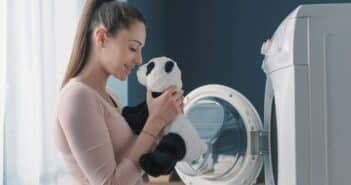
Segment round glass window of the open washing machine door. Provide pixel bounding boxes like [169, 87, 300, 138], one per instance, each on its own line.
[177, 97, 247, 179]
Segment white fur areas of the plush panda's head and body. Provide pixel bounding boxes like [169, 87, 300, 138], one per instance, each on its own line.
[137, 57, 207, 164]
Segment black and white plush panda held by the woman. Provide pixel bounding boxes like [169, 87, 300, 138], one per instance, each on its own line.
[122, 57, 207, 177]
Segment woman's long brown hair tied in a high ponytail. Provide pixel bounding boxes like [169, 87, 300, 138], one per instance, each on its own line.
[61, 0, 146, 88]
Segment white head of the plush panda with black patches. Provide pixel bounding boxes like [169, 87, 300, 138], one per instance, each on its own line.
[137, 56, 182, 92]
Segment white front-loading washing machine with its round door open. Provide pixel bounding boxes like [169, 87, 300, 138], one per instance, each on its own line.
[176, 4, 351, 185]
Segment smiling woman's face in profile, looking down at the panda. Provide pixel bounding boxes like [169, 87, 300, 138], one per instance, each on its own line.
[101, 21, 146, 80]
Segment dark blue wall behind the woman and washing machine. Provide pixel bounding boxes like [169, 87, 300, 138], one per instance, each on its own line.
[128, 0, 347, 116]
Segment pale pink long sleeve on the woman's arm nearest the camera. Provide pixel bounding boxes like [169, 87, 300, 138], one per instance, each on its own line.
[58, 88, 142, 185]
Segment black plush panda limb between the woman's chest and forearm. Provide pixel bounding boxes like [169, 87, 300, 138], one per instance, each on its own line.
[122, 101, 149, 135]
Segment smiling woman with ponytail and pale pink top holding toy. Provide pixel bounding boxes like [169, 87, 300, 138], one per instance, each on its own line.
[54, 0, 183, 185]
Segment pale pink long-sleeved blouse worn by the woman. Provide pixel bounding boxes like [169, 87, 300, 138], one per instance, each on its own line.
[54, 78, 143, 185]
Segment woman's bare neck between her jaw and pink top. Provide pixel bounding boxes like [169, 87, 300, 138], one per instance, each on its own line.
[76, 55, 109, 96]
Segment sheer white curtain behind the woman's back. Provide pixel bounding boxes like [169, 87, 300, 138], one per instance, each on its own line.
[0, 0, 84, 185]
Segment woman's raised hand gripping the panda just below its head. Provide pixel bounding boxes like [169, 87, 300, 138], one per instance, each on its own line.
[147, 86, 184, 128]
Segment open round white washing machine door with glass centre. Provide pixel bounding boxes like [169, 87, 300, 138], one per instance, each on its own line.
[176, 85, 267, 185]
